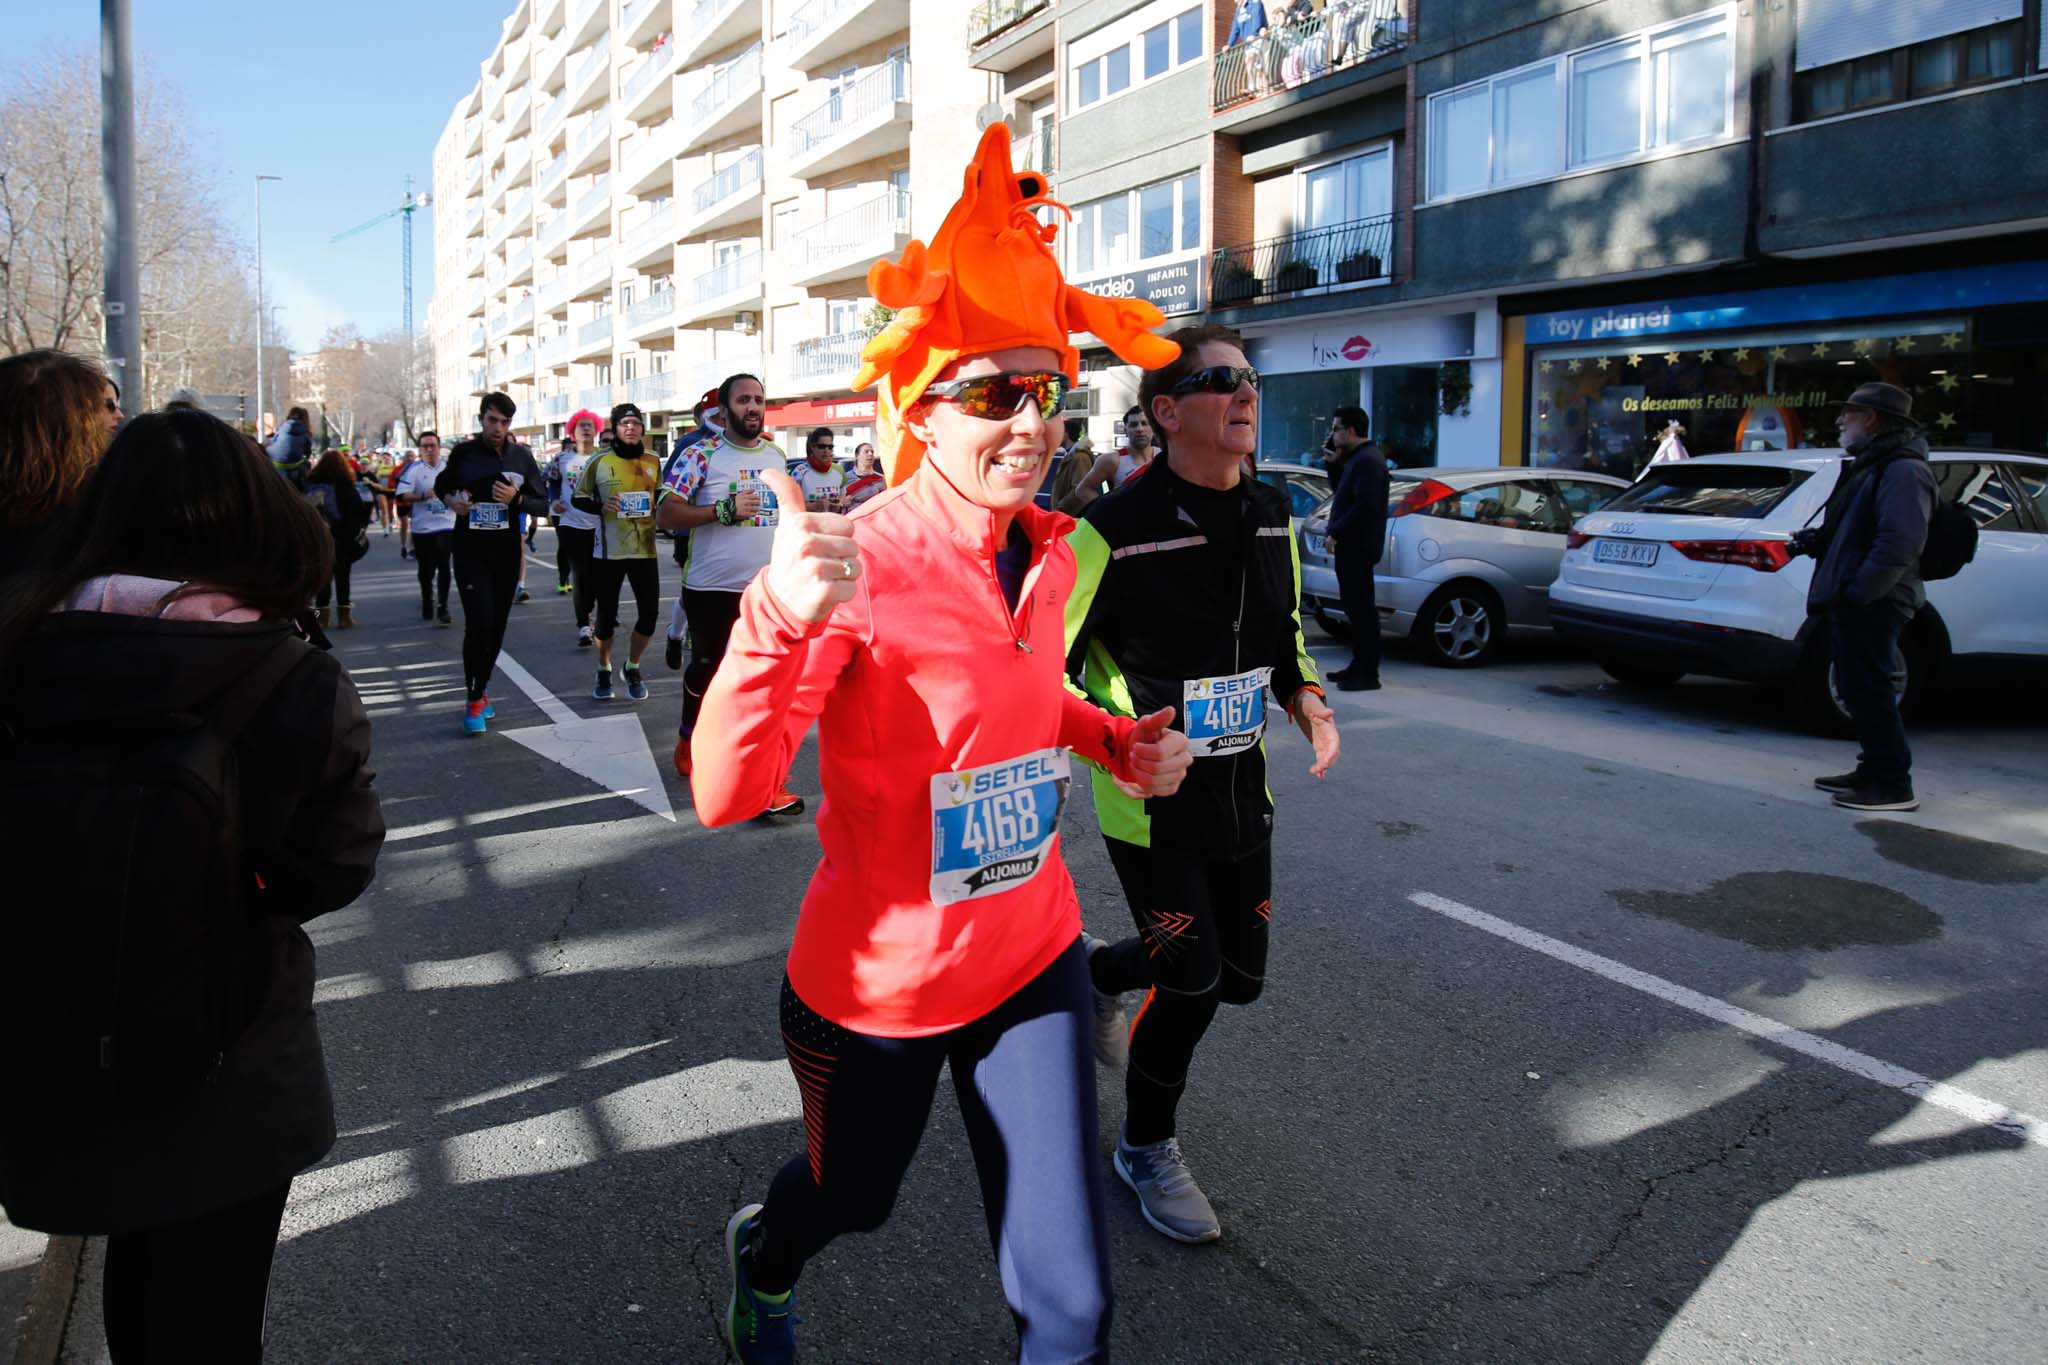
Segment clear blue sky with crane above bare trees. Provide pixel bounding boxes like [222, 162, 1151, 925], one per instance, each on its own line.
[18, 0, 512, 350]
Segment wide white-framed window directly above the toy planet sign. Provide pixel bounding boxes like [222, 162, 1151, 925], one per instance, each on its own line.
[1427, 10, 1735, 199]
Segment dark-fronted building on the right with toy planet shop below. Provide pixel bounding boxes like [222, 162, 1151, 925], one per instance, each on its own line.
[969, 0, 2048, 480]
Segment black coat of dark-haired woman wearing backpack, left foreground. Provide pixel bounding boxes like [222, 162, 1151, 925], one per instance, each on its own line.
[0, 612, 385, 1234]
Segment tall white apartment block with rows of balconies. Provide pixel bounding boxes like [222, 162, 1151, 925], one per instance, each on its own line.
[428, 0, 995, 446]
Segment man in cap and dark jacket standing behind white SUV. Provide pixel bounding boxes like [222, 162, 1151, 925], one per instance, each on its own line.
[1792, 383, 1937, 810]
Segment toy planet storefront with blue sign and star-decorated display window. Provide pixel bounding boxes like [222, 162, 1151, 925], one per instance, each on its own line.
[1526, 262, 2048, 479]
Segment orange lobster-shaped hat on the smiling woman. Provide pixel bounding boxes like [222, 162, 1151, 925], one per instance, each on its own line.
[854, 123, 1180, 485]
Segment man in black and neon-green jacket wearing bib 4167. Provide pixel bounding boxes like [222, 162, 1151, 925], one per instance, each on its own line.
[1067, 327, 1337, 1242]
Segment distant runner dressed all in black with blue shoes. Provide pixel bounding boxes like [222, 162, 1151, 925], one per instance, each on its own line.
[434, 393, 547, 735]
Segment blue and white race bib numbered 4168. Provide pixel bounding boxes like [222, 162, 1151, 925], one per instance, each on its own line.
[932, 749, 1073, 905]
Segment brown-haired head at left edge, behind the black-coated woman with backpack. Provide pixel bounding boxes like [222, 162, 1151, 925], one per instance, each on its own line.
[0, 350, 121, 579]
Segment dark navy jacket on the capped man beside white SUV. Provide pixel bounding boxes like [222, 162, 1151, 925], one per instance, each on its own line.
[1806, 432, 1937, 612]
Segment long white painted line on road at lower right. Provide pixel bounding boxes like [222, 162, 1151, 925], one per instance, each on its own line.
[1409, 890, 2048, 1146]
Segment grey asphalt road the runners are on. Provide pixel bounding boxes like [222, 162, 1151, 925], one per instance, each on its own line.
[74, 532, 2048, 1361]
